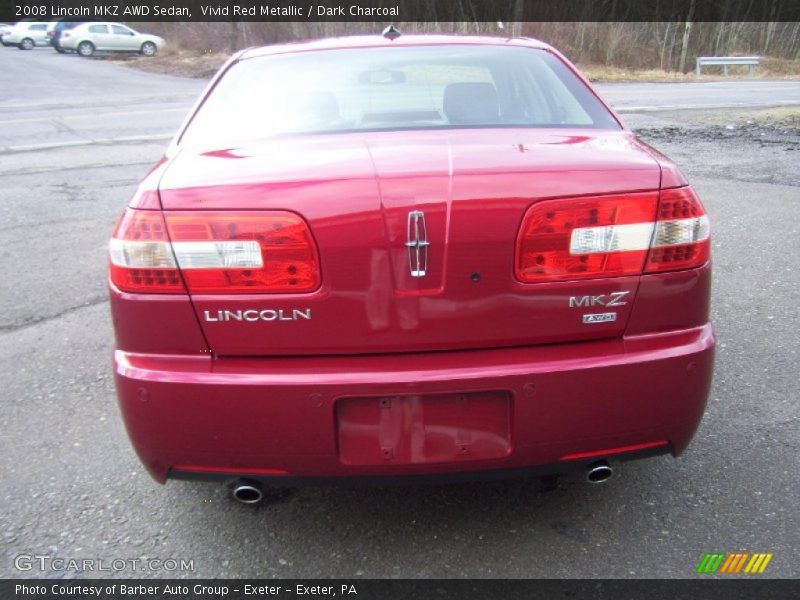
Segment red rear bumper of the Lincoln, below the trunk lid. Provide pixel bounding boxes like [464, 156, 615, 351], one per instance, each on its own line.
[114, 324, 714, 483]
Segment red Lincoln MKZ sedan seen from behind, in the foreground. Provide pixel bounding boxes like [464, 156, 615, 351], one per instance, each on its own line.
[110, 35, 715, 502]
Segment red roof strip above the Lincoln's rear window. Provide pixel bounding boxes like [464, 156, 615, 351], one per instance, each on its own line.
[239, 35, 552, 60]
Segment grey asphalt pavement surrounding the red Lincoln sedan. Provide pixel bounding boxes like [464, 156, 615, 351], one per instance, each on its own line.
[0, 48, 800, 578]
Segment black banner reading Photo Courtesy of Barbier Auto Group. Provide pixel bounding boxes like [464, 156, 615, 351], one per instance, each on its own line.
[0, 576, 800, 600]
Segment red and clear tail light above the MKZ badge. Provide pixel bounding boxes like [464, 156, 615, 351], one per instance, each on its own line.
[515, 187, 710, 283]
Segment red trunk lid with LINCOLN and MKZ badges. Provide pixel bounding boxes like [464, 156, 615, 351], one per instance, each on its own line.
[160, 129, 660, 356]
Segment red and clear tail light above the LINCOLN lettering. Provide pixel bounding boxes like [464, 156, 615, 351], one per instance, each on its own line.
[109, 209, 320, 294]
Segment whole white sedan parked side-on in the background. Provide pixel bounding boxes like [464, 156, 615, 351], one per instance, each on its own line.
[59, 23, 164, 56]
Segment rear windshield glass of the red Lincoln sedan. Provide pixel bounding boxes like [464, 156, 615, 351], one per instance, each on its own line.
[181, 45, 620, 146]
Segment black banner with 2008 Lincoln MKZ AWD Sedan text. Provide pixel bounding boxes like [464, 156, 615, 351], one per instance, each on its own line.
[0, 0, 800, 22]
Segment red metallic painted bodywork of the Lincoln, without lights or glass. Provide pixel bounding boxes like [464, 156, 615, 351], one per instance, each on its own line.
[111, 36, 714, 482]
